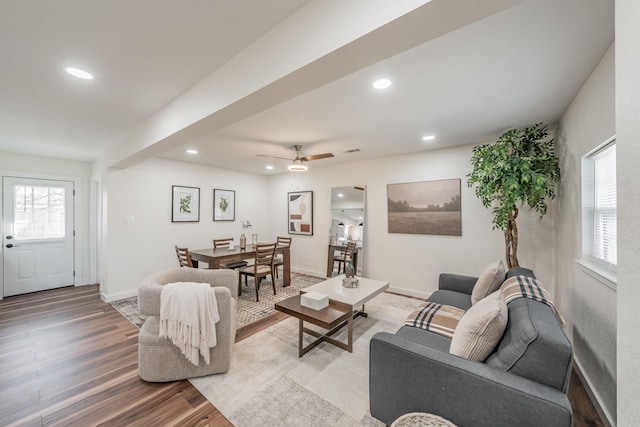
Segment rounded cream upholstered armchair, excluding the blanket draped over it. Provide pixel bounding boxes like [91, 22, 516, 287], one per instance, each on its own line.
[138, 268, 238, 382]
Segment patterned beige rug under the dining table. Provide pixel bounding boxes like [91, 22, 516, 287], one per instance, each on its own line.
[111, 273, 325, 329]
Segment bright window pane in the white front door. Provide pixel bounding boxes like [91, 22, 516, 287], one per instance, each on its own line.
[14, 185, 66, 240]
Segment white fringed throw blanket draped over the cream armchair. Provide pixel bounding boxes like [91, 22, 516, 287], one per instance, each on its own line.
[160, 282, 220, 366]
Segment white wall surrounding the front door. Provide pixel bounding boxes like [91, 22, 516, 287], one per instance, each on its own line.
[0, 152, 91, 298]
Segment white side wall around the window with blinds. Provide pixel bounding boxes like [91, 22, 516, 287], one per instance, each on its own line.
[555, 45, 617, 422]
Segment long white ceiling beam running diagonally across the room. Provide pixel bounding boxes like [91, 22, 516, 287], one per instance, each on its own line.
[103, 0, 521, 169]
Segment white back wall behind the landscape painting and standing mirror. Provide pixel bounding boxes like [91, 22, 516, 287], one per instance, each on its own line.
[269, 146, 554, 296]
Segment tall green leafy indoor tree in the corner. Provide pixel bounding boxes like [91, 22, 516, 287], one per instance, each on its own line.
[467, 123, 560, 268]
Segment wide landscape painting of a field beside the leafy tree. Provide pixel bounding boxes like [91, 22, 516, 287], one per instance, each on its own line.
[387, 179, 462, 236]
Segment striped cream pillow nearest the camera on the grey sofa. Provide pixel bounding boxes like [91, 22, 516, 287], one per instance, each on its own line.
[449, 290, 509, 362]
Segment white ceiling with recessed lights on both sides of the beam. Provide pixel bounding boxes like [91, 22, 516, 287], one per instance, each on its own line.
[0, 0, 614, 174]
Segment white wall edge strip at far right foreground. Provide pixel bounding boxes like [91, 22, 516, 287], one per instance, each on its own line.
[616, 0, 640, 426]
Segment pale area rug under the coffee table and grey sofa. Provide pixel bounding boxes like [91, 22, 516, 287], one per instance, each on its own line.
[190, 293, 421, 427]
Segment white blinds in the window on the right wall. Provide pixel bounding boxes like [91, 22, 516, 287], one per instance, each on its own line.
[592, 144, 618, 266]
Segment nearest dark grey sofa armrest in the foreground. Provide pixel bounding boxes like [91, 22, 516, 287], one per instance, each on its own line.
[369, 332, 573, 427]
